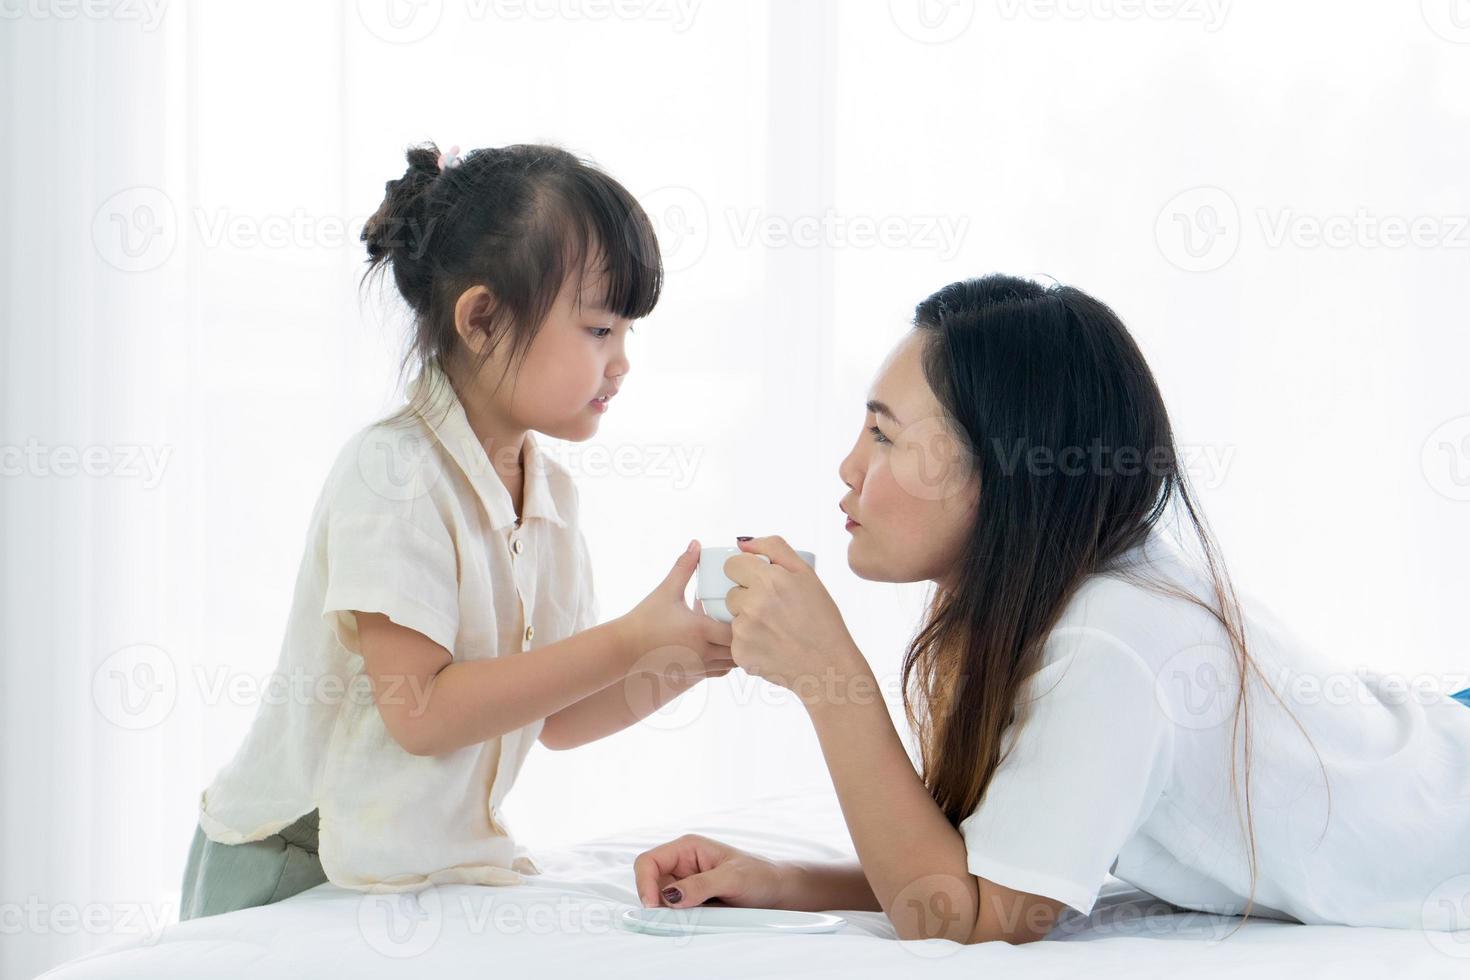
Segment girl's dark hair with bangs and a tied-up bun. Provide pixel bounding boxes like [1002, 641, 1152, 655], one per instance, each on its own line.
[362, 143, 663, 423]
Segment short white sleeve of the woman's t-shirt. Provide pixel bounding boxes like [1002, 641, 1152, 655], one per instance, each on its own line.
[960, 627, 1173, 915]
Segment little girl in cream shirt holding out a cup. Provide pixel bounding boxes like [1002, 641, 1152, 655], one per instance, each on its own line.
[181, 145, 732, 918]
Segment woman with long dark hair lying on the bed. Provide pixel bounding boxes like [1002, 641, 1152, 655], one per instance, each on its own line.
[635, 276, 1470, 943]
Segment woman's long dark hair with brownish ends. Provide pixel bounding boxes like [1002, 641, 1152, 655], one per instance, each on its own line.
[903, 275, 1330, 923]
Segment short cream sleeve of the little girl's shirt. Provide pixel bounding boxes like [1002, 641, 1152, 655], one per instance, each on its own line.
[322, 511, 459, 655]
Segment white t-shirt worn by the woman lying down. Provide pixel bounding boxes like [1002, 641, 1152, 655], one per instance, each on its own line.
[960, 536, 1470, 929]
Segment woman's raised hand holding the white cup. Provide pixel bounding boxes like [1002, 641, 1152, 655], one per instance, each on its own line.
[725, 536, 867, 705]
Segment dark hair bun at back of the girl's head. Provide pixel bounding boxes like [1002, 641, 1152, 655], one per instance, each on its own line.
[362, 143, 440, 313]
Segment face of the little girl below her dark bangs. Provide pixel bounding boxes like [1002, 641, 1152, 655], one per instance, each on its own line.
[462, 275, 632, 442]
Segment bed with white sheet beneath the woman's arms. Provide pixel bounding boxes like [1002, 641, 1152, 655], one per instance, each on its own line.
[43, 792, 1470, 980]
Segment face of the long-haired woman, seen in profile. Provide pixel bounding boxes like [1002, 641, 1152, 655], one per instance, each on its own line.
[838, 329, 979, 585]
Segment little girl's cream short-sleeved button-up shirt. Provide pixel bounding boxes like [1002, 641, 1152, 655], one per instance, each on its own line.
[200, 367, 598, 892]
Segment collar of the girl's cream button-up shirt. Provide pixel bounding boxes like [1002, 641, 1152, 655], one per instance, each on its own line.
[410, 361, 566, 530]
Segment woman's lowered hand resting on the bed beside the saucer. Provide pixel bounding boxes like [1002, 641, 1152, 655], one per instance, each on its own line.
[634, 833, 786, 908]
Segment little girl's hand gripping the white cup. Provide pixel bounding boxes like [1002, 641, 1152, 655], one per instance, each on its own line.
[625, 541, 735, 677]
